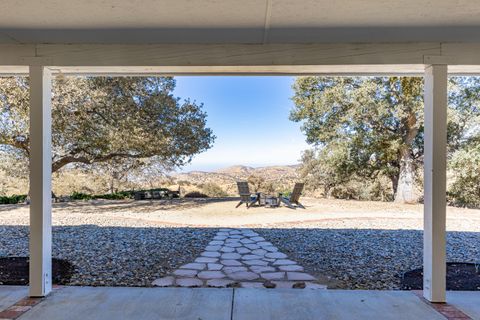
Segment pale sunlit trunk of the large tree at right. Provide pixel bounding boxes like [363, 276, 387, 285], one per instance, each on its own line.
[394, 148, 417, 203]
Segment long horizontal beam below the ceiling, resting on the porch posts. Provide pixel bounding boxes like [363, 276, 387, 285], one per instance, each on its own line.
[0, 42, 450, 67]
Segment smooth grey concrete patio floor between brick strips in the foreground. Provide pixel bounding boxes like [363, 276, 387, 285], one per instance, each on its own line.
[0, 286, 480, 320]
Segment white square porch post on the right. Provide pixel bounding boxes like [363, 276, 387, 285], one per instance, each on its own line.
[423, 65, 447, 302]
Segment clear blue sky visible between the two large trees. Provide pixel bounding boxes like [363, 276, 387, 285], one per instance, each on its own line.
[174, 76, 308, 171]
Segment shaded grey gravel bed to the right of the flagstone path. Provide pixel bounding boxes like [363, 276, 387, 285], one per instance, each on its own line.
[255, 228, 480, 290]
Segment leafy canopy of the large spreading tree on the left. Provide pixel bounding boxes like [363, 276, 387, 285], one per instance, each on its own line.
[0, 76, 215, 172]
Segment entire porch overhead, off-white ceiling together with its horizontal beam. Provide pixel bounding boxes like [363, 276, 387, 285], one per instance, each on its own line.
[0, 0, 480, 75]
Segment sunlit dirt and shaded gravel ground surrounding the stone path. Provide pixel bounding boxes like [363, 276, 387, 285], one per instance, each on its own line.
[0, 199, 480, 289]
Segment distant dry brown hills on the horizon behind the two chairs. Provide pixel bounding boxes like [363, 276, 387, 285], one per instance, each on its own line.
[172, 165, 300, 195]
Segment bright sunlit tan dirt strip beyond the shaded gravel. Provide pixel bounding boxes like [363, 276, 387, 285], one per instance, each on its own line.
[0, 198, 480, 231]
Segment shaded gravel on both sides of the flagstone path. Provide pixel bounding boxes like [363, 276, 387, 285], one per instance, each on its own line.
[0, 225, 480, 289]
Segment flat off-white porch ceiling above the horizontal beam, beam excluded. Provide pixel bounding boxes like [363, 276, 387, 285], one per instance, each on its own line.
[0, 0, 480, 43]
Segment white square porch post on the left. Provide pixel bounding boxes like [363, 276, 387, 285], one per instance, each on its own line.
[30, 66, 52, 297]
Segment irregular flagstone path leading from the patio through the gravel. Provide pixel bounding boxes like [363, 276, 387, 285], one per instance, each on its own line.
[152, 229, 326, 289]
